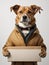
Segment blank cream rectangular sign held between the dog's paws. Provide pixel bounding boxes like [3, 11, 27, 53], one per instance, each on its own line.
[8, 46, 41, 62]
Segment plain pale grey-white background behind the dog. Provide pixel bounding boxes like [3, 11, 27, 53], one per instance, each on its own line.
[0, 0, 49, 65]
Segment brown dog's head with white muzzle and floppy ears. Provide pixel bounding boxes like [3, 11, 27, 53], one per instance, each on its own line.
[10, 5, 42, 27]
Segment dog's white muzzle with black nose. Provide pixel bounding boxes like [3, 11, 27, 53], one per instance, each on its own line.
[18, 15, 31, 28]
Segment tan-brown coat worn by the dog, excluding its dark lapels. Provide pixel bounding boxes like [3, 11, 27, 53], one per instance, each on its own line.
[3, 28, 46, 65]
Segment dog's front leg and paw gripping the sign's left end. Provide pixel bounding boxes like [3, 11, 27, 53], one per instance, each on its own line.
[2, 36, 13, 57]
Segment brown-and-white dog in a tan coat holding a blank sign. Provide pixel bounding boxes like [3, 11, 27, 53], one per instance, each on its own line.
[3, 5, 46, 65]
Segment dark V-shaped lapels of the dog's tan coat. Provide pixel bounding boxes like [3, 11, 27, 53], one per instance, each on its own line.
[16, 24, 39, 45]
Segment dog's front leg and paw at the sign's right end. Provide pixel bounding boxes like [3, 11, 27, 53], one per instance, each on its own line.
[38, 35, 47, 58]
